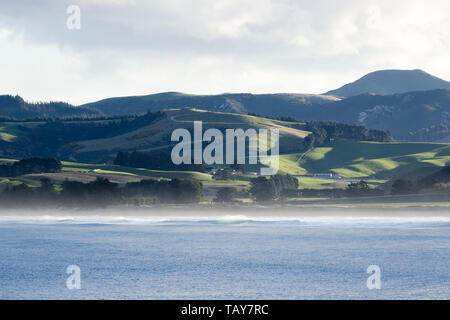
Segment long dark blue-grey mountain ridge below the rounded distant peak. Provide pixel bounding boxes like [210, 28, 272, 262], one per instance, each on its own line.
[83, 89, 450, 141]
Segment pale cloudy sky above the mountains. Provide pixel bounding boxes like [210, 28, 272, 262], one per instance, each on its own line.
[0, 0, 450, 105]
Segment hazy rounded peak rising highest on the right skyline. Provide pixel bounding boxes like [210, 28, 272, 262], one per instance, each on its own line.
[325, 70, 450, 98]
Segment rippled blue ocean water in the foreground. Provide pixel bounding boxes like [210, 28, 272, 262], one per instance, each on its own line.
[0, 215, 450, 299]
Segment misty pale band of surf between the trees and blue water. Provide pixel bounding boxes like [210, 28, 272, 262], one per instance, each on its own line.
[0, 204, 450, 223]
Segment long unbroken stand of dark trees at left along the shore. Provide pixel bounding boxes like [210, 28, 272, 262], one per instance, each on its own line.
[0, 177, 203, 207]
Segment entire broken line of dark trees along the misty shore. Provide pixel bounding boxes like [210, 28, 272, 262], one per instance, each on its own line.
[5, 167, 450, 207]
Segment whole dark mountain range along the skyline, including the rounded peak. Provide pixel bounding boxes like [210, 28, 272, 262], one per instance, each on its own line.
[0, 69, 450, 141]
